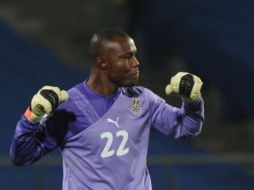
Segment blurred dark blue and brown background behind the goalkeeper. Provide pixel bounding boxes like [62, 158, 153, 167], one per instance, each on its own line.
[0, 0, 254, 190]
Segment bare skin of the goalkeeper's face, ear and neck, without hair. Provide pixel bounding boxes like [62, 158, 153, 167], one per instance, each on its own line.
[87, 37, 139, 96]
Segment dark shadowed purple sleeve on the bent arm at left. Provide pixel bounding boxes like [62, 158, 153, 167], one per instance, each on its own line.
[10, 116, 57, 165]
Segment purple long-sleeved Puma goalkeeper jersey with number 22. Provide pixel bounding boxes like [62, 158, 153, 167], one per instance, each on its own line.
[10, 83, 204, 190]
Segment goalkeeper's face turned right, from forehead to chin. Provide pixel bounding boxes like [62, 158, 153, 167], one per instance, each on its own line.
[106, 37, 139, 87]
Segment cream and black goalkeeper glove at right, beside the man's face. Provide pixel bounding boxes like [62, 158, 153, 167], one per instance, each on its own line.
[165, 72, 203, 103]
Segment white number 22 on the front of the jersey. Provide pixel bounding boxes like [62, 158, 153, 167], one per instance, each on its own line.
[101, 130, 129, 158]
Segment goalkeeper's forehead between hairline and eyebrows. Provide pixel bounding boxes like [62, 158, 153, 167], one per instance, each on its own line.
[106, 37, 137, 54]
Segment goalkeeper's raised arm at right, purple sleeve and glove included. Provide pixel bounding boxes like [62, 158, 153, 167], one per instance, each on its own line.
[151, 72, 204, 138]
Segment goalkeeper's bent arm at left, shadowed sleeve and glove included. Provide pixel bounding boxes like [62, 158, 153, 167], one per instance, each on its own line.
[10, 86, 68, 165]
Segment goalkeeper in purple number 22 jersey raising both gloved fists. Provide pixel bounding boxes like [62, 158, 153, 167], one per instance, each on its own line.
[10, 28, 204, 190]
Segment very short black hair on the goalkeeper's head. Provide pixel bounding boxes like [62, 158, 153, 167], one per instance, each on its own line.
[89, 28, 130, 57]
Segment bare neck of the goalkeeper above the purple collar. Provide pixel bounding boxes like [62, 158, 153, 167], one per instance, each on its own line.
[87, 69, 118, 96]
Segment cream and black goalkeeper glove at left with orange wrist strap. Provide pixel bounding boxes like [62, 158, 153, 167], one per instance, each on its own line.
[25, 86, 69, 123]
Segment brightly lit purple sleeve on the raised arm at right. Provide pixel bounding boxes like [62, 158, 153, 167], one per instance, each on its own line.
[151, 87, 204, 138]
